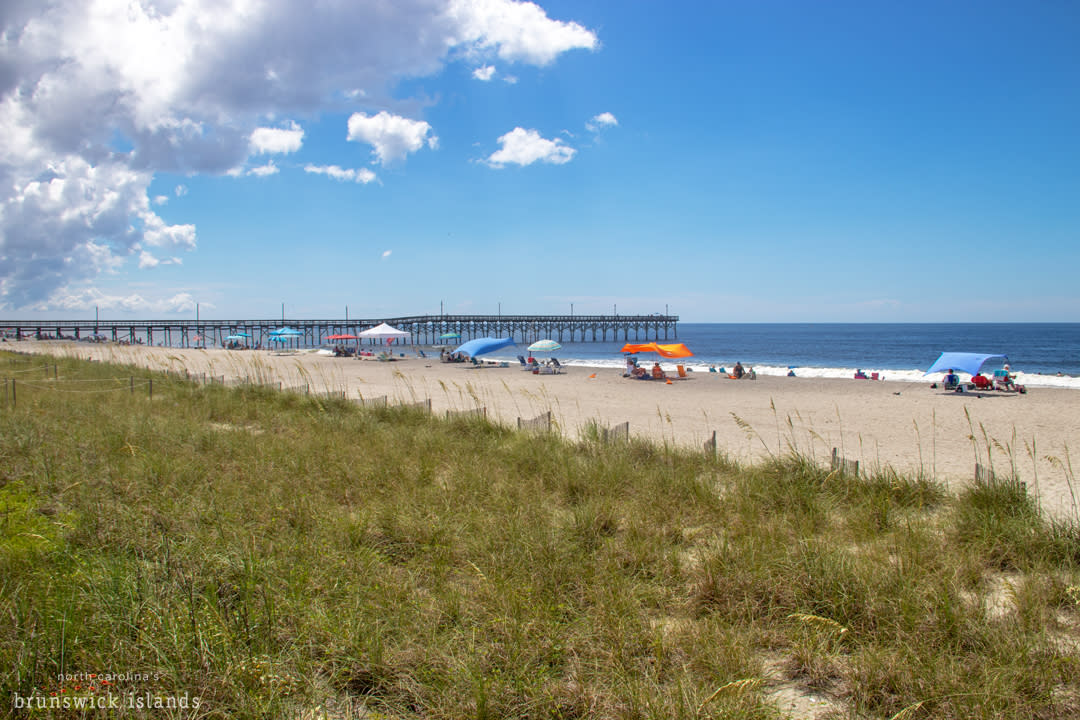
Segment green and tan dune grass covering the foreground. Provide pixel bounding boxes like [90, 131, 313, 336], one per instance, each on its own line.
[6, 355, 1080, 719]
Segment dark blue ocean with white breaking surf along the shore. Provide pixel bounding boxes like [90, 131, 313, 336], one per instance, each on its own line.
[487, 323, 1080, 390]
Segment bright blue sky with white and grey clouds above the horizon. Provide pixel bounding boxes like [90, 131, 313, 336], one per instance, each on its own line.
[0, 0, 1080, 322]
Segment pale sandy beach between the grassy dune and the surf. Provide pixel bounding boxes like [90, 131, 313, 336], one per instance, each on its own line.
[5, 341, 1080, 520]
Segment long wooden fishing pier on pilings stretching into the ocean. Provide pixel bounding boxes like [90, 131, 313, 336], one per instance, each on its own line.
[0, 314, 678, 348]
